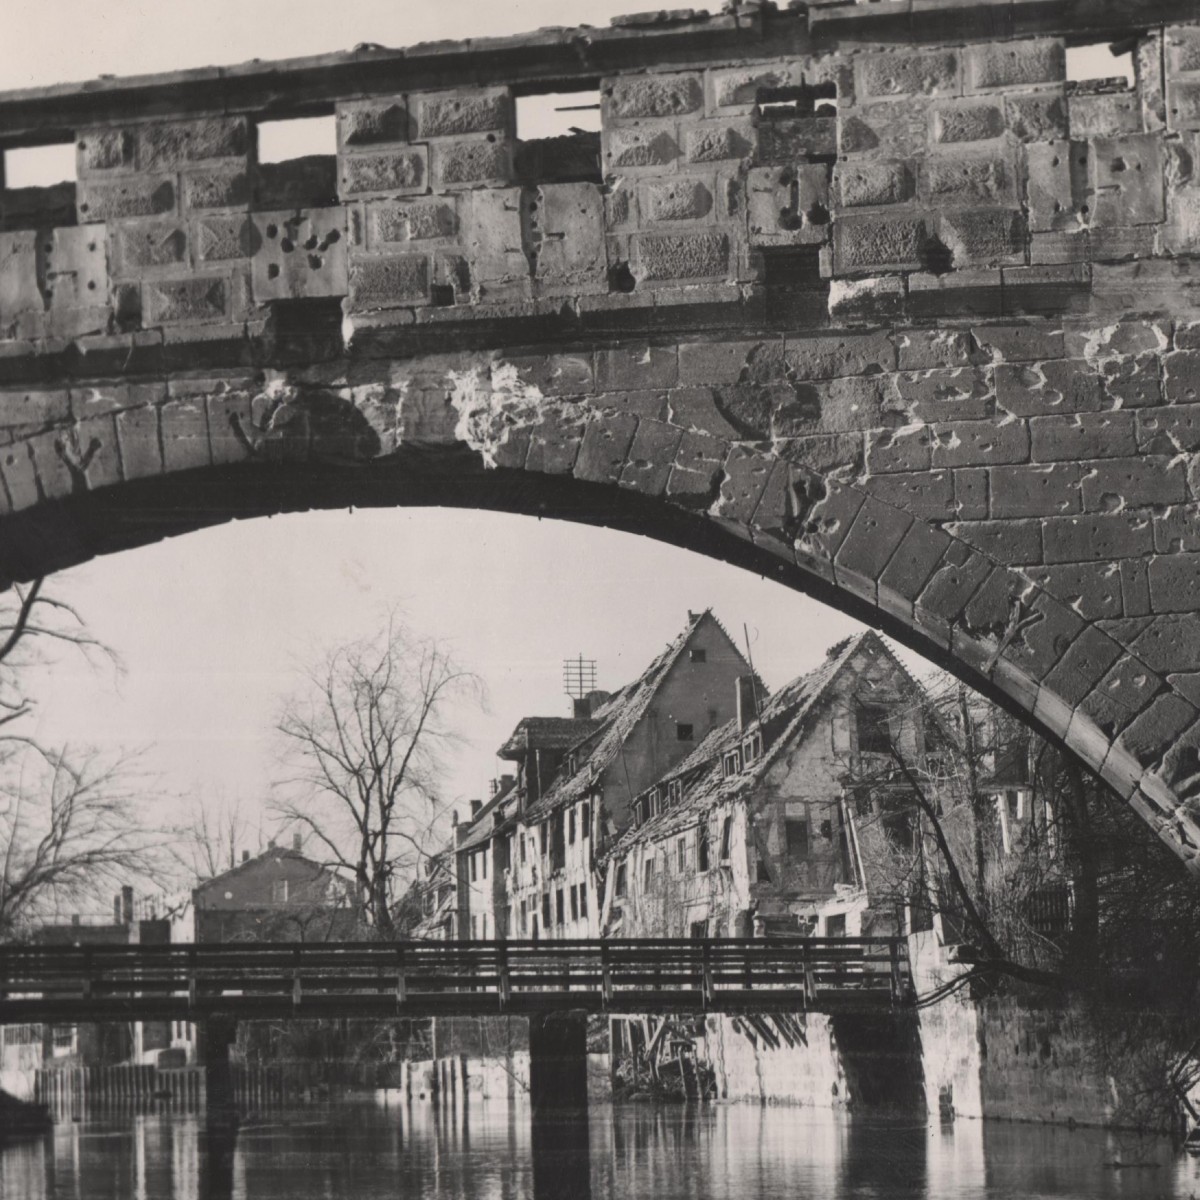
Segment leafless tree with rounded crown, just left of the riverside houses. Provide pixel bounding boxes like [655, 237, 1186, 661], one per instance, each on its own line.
[275, 613, 482, 937]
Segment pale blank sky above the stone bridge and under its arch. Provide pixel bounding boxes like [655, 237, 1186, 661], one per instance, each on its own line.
[7, 0, 1113, 864]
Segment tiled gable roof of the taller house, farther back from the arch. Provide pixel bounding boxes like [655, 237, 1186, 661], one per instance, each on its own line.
[527, 608, 749, 821]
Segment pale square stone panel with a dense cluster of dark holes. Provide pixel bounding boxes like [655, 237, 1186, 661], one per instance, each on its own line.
[251, 208, 349, 304]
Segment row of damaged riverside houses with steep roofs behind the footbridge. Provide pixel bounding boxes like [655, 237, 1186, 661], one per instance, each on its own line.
[413, 611, 1017, 940]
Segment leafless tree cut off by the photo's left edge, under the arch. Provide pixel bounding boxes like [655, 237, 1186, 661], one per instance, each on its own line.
[0, 580, 155, 940]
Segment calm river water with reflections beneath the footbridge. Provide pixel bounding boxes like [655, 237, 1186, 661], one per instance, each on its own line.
[0, 1093, 1200, 1200]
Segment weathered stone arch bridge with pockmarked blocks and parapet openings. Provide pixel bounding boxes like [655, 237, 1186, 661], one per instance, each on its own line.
[0, 0, 1200, 868]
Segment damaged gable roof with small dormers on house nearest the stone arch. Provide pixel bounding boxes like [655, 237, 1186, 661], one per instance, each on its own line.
[605, 630, 919, 859]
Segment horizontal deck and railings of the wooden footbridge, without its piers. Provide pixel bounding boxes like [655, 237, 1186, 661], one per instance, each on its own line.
[0, 937, 910, 1024]
